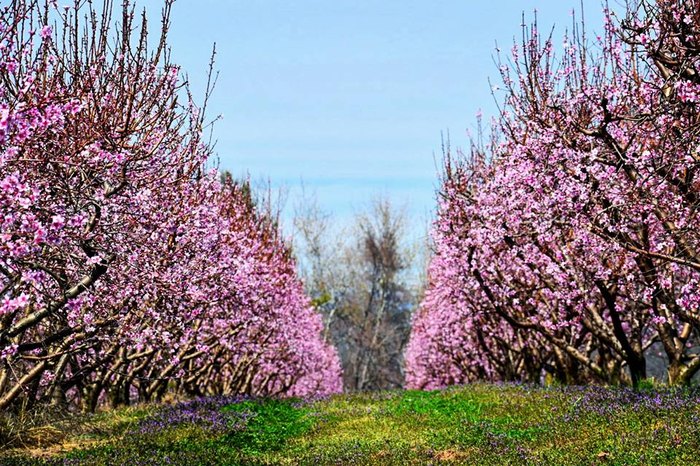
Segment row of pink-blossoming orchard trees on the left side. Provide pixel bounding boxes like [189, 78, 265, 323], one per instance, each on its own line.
[0, 0, 341, 409]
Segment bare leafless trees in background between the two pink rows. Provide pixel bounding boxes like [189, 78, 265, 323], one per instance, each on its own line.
[295, 198, 421, 391]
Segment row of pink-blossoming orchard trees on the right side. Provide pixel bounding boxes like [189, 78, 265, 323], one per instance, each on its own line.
[406, 1, 700, 388]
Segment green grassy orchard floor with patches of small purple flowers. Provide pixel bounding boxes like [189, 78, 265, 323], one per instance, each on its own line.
[0, 384, 700, 466]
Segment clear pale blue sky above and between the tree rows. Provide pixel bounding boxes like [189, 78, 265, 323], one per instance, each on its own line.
[137, 0, 601, 233]
